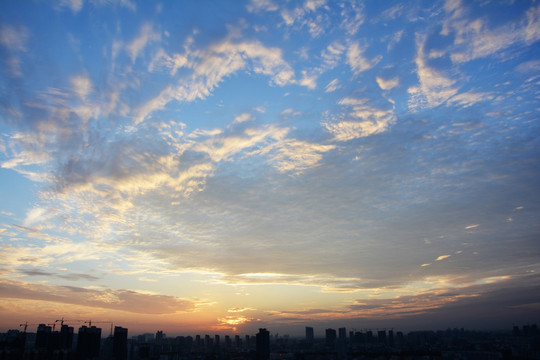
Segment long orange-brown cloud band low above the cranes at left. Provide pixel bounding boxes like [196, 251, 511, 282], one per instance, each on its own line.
[0, 280, 196, 315]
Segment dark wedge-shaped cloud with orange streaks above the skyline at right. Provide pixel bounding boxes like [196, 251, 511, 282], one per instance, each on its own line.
[271, 276, 538, 330]
